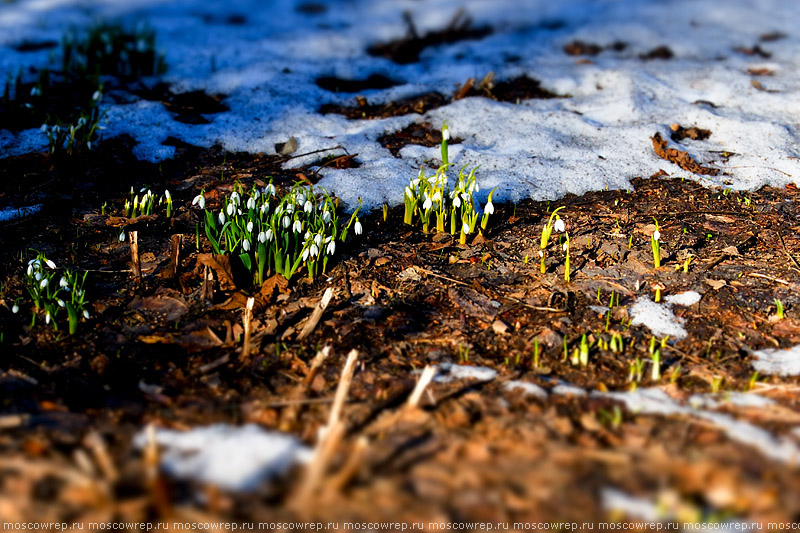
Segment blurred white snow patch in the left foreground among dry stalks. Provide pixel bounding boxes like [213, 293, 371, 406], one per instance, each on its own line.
[134, 424, 311, 491]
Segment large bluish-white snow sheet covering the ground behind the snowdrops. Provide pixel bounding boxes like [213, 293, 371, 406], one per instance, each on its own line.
[0, 0, 800, 209]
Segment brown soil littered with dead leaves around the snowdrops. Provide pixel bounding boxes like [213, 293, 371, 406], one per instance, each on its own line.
[0, 136, 800, 529]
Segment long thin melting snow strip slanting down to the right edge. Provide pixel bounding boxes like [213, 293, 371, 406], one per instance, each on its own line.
[593, 388, 800, 465]
